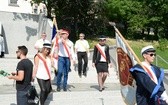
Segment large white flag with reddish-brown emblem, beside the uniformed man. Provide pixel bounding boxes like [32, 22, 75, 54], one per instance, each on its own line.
[115, 32, 137, 105]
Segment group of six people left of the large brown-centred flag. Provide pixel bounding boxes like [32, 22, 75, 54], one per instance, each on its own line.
[5, 29, 111, 105]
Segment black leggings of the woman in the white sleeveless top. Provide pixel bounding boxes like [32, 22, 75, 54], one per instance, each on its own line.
[37, 79, 51, 105]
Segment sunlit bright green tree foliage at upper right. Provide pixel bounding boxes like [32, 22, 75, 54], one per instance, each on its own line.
[106, 0, 168, 39]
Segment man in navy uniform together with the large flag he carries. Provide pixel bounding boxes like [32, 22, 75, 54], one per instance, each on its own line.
[110, 23, 168, 105]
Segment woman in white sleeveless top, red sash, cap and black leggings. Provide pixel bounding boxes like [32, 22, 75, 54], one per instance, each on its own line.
[33, 42, 53, 105]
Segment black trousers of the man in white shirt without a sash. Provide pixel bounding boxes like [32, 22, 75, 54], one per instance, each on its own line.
[77, 52, 88, 75]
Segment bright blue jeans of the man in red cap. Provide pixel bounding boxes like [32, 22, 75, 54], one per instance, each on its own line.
[57, 56, 70, 88]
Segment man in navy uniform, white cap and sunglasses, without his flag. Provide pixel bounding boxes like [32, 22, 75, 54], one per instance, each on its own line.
[130, 45, 168, 105]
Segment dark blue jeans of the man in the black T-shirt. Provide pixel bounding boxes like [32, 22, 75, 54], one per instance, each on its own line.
[16, 91, 28, 105]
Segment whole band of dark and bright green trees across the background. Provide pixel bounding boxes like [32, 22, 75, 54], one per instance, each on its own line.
[30, 0, 168, 40]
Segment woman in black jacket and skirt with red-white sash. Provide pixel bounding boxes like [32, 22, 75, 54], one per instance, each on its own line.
[92, 35, 112, 92]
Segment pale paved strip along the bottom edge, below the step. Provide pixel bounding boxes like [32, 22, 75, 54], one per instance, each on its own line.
[0, 91, 125, 105]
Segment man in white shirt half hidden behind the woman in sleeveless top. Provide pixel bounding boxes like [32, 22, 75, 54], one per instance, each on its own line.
[34, 32, 50, 52]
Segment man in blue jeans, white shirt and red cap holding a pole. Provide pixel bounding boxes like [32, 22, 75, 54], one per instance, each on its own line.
[57, 29, 75, 92]
